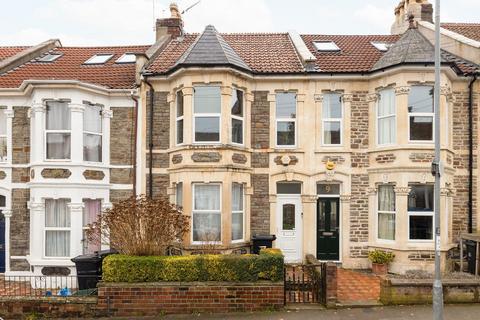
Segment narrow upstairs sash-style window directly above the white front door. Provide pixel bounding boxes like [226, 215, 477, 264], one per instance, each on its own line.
[275, 92, 297, 147]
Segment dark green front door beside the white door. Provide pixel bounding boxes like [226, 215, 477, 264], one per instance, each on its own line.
[317, 198, 340, 261]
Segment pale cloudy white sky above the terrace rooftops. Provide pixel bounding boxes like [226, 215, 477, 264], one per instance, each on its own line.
[0, 0, 480, 46]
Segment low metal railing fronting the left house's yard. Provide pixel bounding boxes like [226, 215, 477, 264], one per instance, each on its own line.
[0, 275, 101, 297]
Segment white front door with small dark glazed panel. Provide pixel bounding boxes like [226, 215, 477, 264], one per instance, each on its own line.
[276, 195, 303, 262]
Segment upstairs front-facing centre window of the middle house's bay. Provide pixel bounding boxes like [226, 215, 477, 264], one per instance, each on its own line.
[193, 86, 222, 143]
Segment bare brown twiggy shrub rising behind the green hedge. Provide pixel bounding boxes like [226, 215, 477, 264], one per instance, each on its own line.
[86, 196, 189, 256]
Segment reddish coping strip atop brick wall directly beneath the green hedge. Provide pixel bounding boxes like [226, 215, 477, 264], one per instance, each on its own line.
[97, 281, 284, 288]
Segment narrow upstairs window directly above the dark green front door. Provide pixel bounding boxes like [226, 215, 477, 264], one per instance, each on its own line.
[322, 93, 343, 146]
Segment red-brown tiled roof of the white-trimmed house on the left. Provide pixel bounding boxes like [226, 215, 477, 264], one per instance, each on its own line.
[0, 46, 149, 89]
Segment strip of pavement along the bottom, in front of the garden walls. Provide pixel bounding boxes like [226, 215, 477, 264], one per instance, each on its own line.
[84, 303, 480, 320]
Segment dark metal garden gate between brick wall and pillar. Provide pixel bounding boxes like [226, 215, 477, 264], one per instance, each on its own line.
[284, 263, 327, 304]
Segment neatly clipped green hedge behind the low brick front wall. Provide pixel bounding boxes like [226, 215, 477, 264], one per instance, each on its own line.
[103, 250, 283, 282]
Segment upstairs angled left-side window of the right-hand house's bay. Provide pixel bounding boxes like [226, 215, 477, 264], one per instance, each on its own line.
[377, 89, 397, 145]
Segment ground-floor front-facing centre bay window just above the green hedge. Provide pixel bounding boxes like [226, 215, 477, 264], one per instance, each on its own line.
[192, 183, 222, 243]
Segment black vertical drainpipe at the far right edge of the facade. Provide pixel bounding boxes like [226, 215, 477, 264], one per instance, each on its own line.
[468, 75, 477, 233]
